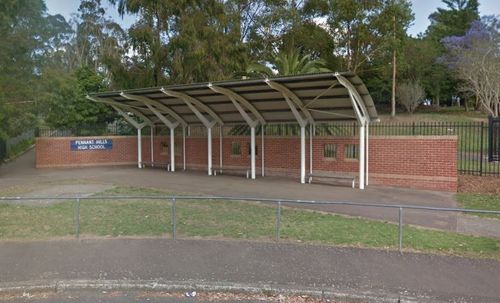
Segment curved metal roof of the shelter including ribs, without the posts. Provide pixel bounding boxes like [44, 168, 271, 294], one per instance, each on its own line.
[88, 72, 378, 125]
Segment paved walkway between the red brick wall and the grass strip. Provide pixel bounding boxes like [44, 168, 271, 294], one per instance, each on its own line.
[0, 151, 457, 231]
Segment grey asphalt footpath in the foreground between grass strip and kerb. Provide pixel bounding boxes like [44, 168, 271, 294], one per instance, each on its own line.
[0, 239, 500, 302]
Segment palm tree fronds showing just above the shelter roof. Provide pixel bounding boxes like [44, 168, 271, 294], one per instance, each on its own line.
[244, 50, 331, 77]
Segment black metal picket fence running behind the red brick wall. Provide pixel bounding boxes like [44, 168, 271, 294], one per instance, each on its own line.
[37, 119, 500, 177]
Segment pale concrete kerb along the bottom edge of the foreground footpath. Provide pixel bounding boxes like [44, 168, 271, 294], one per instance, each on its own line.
[0, 280, 434, 303]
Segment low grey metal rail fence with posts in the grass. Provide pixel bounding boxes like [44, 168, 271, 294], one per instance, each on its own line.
[0, 195, 500, 253]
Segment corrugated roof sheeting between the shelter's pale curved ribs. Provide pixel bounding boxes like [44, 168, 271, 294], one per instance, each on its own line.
[90, 72, 377, 125]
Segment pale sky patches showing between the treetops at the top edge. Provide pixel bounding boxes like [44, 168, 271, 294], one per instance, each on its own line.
[45, 0, 500, 36]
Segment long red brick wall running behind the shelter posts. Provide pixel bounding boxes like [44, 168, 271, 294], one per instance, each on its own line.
[36, 136, 457, 191]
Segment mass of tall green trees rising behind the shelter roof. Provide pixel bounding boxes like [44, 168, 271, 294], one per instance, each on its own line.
[0, 0, 498, 136]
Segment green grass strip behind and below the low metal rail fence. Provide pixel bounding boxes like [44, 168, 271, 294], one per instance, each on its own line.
[0, 187, 500, 260]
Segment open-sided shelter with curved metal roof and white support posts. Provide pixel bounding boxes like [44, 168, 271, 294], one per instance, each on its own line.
[87, 72, 378, 189]
